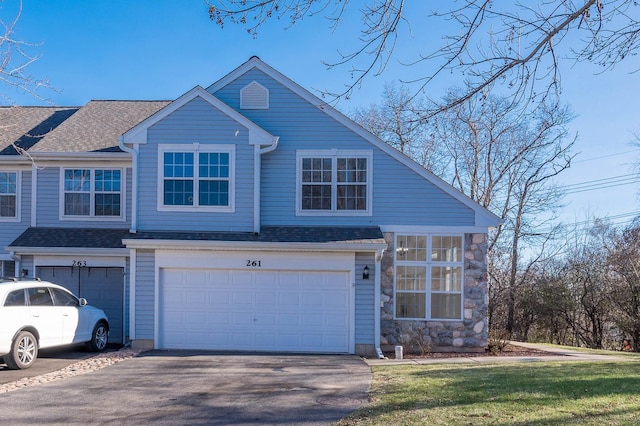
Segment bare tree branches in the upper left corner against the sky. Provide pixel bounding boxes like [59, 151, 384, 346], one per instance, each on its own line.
[0, 0, 51, 103]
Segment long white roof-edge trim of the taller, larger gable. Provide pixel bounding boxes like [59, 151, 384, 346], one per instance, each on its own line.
[207, 56, 502, 227]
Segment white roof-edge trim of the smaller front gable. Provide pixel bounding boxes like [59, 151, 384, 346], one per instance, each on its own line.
[121, 86, 274, 145]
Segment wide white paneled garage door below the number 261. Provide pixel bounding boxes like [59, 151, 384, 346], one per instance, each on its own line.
[158, 268, 350, 353]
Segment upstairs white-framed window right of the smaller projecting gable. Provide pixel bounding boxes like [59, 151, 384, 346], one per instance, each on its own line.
[297, 150, 372, 215]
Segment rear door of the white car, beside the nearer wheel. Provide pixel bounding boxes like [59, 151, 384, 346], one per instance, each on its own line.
[27, 286, 63, 348]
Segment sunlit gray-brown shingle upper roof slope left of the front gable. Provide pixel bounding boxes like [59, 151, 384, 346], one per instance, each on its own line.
[30, 101, 170, 152]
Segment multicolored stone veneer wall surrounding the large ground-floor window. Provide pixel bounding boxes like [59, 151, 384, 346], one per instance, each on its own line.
[380, 233, 489, 352]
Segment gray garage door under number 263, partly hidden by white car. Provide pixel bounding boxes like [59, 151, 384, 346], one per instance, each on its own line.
[36, 266, 125, 343]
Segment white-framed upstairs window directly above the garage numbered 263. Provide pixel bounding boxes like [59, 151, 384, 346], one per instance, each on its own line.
[62, 168, 123, 219]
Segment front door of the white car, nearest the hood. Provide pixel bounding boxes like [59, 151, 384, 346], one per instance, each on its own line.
[50, 287, 92, 344]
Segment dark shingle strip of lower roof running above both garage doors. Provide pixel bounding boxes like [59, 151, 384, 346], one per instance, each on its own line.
[9, 226, 385, 248]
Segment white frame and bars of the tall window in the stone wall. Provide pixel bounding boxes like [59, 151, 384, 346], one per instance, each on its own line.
[393, 232, 465, 322]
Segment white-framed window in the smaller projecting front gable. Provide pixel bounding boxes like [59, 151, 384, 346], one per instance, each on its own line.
[158, 144, 235, 212]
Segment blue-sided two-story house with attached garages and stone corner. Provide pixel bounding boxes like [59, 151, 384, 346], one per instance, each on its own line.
[0, 57, 499, 356]
